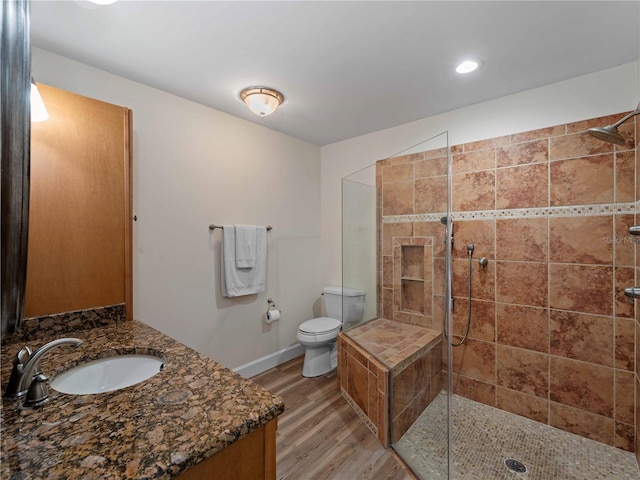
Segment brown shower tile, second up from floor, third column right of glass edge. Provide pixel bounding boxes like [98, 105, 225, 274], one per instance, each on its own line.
[549, 356, 613, 418]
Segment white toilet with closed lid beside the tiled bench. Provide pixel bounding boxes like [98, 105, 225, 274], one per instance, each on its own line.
[297, 286, 364, 377]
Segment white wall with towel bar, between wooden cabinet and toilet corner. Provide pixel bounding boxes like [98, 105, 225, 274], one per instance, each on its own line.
[32, 49, 322, 368]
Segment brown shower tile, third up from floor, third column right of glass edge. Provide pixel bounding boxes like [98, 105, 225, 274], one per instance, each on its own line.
[549, 310, 613, 367]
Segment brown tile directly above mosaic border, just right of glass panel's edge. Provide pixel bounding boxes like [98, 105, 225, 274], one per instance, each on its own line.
[450, 170, 495, 212]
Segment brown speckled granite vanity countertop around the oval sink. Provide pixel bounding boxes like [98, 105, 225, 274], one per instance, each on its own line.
[0, 321, 284, 479]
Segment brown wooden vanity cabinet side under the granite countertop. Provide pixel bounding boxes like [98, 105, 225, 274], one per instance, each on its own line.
[177, 418, 278, 480]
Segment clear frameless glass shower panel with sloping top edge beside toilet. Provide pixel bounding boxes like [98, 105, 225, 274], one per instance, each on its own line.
[342, 132, 452, 479]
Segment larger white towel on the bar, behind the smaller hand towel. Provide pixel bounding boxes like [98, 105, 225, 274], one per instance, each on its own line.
[220, 225, 267, 297]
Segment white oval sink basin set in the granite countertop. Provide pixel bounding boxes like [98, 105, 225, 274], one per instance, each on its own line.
[50, 354, 166, 395]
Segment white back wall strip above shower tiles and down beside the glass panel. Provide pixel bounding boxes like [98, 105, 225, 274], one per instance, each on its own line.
[321, 63, 640, 284]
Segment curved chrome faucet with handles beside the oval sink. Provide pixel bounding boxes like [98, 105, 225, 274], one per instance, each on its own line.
[4, 338, 82, 407]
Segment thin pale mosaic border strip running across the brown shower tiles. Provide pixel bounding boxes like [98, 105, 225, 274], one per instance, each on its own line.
[382, 202, 639, 223]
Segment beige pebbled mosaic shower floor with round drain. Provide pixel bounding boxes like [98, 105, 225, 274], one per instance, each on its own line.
[394, 393, 640, 480]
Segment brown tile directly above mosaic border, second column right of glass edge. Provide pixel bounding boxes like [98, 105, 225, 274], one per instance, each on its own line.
[496, 163, 549, 209]
